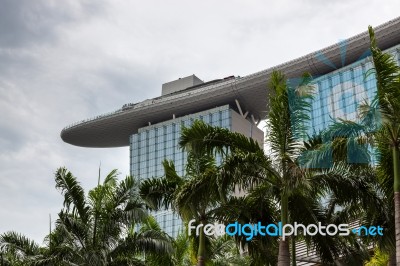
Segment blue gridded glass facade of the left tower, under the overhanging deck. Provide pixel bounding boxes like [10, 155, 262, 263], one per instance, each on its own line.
[130, 105, 232, 237]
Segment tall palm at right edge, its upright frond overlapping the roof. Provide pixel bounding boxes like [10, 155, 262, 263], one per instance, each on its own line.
[368, 26, 400, 265]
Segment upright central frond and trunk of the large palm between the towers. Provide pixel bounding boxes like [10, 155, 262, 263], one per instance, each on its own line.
[267, 72, 311, 266]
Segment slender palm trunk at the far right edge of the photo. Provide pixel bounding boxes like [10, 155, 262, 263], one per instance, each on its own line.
[392, 145, 400, 265]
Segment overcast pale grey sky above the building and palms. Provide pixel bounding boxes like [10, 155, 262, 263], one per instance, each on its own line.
[0, 0, 400, 243]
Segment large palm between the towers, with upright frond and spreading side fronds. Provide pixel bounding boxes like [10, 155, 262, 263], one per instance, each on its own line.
[182, 72, 381, 265]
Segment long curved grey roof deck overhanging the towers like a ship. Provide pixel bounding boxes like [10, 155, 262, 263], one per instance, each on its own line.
[61, 17, 400, 147]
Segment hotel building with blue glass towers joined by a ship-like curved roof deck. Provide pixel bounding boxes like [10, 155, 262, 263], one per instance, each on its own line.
[61, 18, 400, 265]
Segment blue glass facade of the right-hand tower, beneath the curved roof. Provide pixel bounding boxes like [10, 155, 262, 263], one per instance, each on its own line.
[308, 46, 400, 135]
